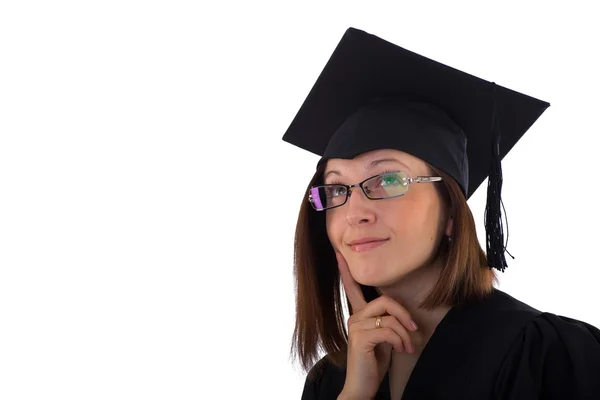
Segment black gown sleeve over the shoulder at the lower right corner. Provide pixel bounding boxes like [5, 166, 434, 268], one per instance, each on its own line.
[494, 312, 600, 399]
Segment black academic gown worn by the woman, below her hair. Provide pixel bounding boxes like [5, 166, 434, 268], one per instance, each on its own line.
[302, 289, 600, 400]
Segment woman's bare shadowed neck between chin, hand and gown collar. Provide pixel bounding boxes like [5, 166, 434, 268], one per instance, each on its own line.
[377, 263, 451, 347]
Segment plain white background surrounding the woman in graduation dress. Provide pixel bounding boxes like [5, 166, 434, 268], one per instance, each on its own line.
[0, 0, 600, 399]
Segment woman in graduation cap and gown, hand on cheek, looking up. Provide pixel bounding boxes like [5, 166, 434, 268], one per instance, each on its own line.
[284, 29, 600, 400]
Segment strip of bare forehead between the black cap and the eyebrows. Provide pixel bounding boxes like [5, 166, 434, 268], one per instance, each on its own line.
[325, 149, 426, 172]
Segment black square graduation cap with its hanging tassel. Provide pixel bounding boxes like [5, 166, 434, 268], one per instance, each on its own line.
[283, 28, 550, 271]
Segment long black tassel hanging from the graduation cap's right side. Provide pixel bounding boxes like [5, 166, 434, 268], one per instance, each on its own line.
[484, 83, 514, 272]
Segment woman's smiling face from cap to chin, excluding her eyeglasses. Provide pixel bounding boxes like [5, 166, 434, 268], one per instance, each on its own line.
[324, 149, 451, 287]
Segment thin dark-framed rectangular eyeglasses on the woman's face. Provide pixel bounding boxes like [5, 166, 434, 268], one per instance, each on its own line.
[308, 171, 442, 211]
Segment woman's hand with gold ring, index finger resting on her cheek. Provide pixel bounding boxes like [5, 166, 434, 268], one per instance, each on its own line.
[336, 251, 417, 399]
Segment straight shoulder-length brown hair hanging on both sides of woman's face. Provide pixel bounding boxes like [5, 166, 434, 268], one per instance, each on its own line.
[291, 163, 497, 379]
